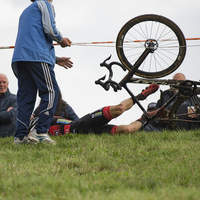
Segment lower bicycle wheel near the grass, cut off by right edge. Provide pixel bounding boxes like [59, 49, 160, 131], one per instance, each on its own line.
[169, 95, 200, 130]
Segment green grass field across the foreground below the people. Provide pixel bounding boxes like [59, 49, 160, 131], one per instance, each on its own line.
[0, 131, 200, 200]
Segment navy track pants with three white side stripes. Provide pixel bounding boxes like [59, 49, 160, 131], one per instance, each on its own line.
[15, 62, 59, 137]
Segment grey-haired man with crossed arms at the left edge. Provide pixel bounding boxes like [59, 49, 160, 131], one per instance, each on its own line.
[0, 74, 17, 137]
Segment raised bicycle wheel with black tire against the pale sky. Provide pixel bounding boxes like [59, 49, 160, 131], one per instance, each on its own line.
[116, 14, 186, 78]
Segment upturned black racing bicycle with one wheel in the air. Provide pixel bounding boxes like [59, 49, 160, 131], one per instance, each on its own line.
[95, 15, 200, 130]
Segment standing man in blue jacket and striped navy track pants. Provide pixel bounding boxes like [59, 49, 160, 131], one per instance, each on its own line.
[12, 0, 73, 144]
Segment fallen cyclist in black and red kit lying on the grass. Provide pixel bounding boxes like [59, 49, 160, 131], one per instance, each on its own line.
[29, 84, 162, 137]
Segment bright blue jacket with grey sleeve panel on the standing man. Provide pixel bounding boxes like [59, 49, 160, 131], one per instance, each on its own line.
[12, 0, 63, 75]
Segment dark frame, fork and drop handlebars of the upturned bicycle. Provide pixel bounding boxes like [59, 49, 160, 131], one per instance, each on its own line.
[95, 55, 200, 130]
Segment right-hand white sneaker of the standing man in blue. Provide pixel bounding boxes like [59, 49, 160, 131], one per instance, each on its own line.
[28, 129, 56, 144]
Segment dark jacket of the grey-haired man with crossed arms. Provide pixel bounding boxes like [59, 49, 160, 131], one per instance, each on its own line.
[0, 89, 17, 137]
